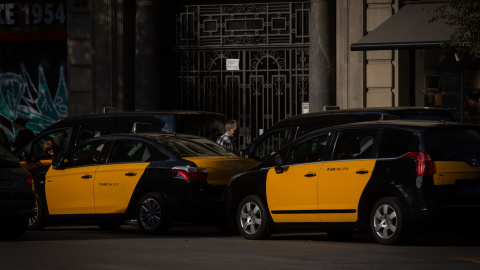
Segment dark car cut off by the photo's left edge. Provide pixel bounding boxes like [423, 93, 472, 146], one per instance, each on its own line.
[0, 146, 36, 239]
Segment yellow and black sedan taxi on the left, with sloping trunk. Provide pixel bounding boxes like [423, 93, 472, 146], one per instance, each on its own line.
[31, 133, 257, 234]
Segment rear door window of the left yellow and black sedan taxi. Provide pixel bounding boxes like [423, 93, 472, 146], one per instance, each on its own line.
[107, 140, 150, 163]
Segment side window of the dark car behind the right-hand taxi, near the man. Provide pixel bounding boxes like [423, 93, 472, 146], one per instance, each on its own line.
[251, 129, 290, 160]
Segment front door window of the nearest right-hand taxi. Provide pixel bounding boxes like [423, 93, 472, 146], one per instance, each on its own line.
[284, 133, 329, 165]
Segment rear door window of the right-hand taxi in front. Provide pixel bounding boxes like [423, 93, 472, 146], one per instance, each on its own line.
[332, 130, 377, 160]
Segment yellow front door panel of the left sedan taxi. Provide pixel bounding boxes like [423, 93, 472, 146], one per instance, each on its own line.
[45, 165, 98, 215]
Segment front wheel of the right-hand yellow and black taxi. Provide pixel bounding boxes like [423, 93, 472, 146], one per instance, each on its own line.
[237, 195, 271, 240]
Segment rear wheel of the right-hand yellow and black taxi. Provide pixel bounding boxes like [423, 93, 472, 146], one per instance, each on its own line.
[370, 197, 407, 245]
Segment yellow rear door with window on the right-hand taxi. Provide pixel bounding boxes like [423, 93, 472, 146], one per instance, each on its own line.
[318, 130, 377, 222]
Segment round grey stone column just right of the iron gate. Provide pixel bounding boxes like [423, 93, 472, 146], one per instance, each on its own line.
[309, 0, 336, 112]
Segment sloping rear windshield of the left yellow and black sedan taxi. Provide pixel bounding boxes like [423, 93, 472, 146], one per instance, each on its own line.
[156, 137, 236, 157]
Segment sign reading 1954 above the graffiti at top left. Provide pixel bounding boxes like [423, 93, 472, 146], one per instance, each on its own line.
[0, 1, 67, 26]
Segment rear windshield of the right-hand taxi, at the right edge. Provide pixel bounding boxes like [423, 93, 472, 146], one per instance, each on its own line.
[425, 127, 480, 165]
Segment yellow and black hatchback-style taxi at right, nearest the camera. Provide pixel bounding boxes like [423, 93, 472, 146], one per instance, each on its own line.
[227, 120, 480, 245]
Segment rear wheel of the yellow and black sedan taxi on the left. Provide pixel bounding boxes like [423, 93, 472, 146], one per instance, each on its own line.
[137, 193, 170, 234]
